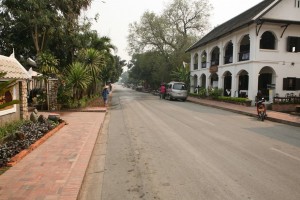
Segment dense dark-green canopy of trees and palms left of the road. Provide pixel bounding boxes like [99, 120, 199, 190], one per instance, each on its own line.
[0, 0, 126, 107]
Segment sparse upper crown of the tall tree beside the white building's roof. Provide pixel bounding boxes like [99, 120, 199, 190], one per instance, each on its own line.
[128, 0, 211, 67]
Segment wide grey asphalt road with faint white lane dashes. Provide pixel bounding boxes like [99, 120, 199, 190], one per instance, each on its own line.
[79, 86, 300, 200]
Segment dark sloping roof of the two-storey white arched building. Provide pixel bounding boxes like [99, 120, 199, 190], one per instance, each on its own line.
[186, 0, 280, 52]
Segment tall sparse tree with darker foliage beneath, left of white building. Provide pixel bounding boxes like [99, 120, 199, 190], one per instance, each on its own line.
[128, 0, 211, 88]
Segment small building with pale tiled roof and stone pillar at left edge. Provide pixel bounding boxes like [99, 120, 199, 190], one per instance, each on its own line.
[0, 54, 31, 126]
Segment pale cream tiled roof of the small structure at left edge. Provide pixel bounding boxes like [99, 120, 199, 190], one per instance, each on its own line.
[0, 55, 31, 79]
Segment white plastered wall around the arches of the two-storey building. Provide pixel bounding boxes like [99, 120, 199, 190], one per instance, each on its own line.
[191, 20, 300, 100]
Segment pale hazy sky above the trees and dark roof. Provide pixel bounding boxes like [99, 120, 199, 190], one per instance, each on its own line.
[86, 0, 262, 61]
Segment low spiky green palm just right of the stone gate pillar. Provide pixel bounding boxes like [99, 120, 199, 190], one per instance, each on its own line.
[66, 62, 92, 103]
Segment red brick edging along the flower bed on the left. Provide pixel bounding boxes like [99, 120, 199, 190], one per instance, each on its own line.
[6, 122, 66, 167]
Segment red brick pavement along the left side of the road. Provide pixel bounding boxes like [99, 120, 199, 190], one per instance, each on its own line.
[0, 108, 106, 200]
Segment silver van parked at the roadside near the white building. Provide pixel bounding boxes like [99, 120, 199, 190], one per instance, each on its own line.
[166, 81, 188, 101]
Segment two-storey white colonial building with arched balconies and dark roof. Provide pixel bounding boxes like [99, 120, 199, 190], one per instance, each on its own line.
[187, 0, 300, 102]
